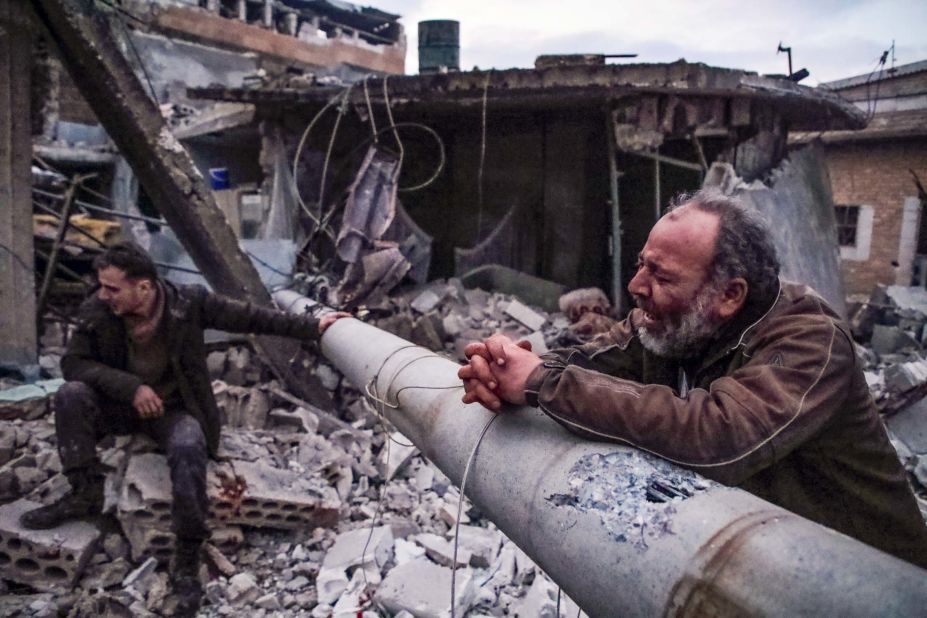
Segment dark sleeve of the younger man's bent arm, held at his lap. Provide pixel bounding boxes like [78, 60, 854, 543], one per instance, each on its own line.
[61, 323, 142, 404]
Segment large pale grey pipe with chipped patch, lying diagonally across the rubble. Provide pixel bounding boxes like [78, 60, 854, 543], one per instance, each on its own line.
[321, 319, 927, 616]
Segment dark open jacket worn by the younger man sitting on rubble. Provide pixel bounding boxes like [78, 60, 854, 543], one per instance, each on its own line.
[61, 282, 319, 455]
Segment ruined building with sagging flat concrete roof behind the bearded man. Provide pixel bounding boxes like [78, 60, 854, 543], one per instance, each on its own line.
[190, 58, 863, 316]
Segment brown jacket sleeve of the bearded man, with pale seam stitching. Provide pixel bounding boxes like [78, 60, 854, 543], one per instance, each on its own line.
[525, 316, 856, 485]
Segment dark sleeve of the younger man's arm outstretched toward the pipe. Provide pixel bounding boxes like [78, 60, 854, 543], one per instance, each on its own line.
[188, 286, 319, 340]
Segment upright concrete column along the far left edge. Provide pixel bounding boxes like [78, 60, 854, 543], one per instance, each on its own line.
[0, 0, 37, 367]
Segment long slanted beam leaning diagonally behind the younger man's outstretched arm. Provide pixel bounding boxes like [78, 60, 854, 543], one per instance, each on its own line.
[32, 0, 331, 408]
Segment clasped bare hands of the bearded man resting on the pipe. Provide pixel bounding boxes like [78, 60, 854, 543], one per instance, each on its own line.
[457, 335, 542, 411]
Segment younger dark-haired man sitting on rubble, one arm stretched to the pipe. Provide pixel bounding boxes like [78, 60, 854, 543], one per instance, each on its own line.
[21, 243, 348, 614]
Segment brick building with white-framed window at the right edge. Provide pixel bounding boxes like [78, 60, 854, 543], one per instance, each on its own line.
[791, 58, 927, 301]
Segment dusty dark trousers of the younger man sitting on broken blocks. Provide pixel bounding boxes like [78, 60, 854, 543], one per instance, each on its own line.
[55, 382, 209, 541]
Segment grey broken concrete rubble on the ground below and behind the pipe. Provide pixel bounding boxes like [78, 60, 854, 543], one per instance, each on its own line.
[0, 288, 578, 617]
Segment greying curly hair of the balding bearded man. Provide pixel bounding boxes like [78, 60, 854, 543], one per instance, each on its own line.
[670, 189, 780, 298]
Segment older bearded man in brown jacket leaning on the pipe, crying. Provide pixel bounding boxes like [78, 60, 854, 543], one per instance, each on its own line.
[459, 192, 927, 567]
